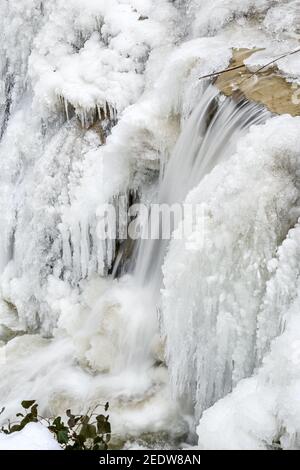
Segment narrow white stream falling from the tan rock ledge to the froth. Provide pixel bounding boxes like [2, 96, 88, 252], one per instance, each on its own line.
[123, 85, 270, 367]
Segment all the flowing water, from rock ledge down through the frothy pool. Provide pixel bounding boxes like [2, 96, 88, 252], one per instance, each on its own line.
[1, 79, 269, 442]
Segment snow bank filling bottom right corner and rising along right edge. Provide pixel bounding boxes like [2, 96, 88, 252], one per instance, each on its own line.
[198, 224, 300, 450]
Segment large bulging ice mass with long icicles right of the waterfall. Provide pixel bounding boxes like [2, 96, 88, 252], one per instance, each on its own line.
[163, 116, 300, 415]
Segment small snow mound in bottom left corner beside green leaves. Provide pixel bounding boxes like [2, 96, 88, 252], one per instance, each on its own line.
[0, 423, 61, 450]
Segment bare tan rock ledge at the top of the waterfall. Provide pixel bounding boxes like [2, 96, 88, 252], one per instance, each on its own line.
[216, 49, 300, 116]
